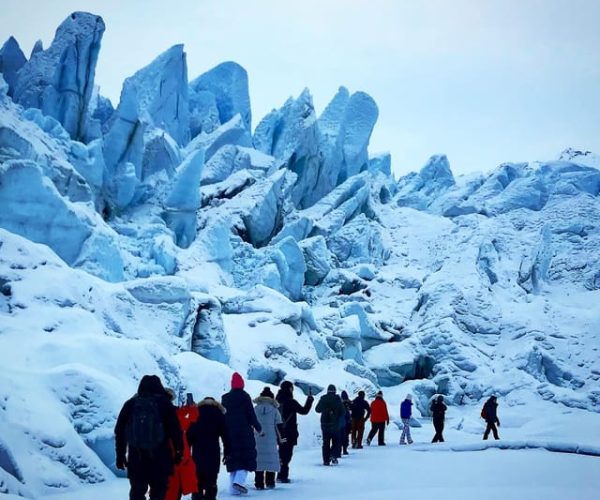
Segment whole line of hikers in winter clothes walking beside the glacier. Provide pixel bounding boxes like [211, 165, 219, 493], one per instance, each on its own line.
[115, 373, 500, 500]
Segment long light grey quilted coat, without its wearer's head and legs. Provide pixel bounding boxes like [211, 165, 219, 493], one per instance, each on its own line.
[254, 396, 281, 472]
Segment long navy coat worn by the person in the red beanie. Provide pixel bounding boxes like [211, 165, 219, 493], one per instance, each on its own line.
[221, 389, 262, 472]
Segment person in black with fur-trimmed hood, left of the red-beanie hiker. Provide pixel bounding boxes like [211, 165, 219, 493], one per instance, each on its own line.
[187, 397, 229, 500]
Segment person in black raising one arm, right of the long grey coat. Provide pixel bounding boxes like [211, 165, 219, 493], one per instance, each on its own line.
[276, 380, 314, 483]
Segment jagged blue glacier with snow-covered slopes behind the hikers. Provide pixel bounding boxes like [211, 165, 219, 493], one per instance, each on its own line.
[0, 12, 600, 498]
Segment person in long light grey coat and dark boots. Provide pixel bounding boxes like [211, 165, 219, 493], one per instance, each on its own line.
[254, 387, 282, 490]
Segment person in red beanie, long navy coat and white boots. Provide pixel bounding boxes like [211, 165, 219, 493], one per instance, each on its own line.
[221, 372, 262, 495]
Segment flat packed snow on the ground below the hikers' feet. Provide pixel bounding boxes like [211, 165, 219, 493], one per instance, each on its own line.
[49, 430, 600, 500]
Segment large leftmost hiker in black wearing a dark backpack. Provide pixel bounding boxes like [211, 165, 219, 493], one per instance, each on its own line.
[115, 375, 183, 500]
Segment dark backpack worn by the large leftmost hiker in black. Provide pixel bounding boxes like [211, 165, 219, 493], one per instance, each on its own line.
[125, 397, 165, 450]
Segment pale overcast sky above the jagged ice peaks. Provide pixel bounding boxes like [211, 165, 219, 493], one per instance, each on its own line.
[0, 0, 600, 175]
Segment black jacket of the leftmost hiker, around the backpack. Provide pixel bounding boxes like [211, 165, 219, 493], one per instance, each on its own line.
[115, 393, 183, 480]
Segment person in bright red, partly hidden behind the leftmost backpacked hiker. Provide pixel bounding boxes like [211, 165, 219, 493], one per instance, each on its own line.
[165, 393, 198, 500]
